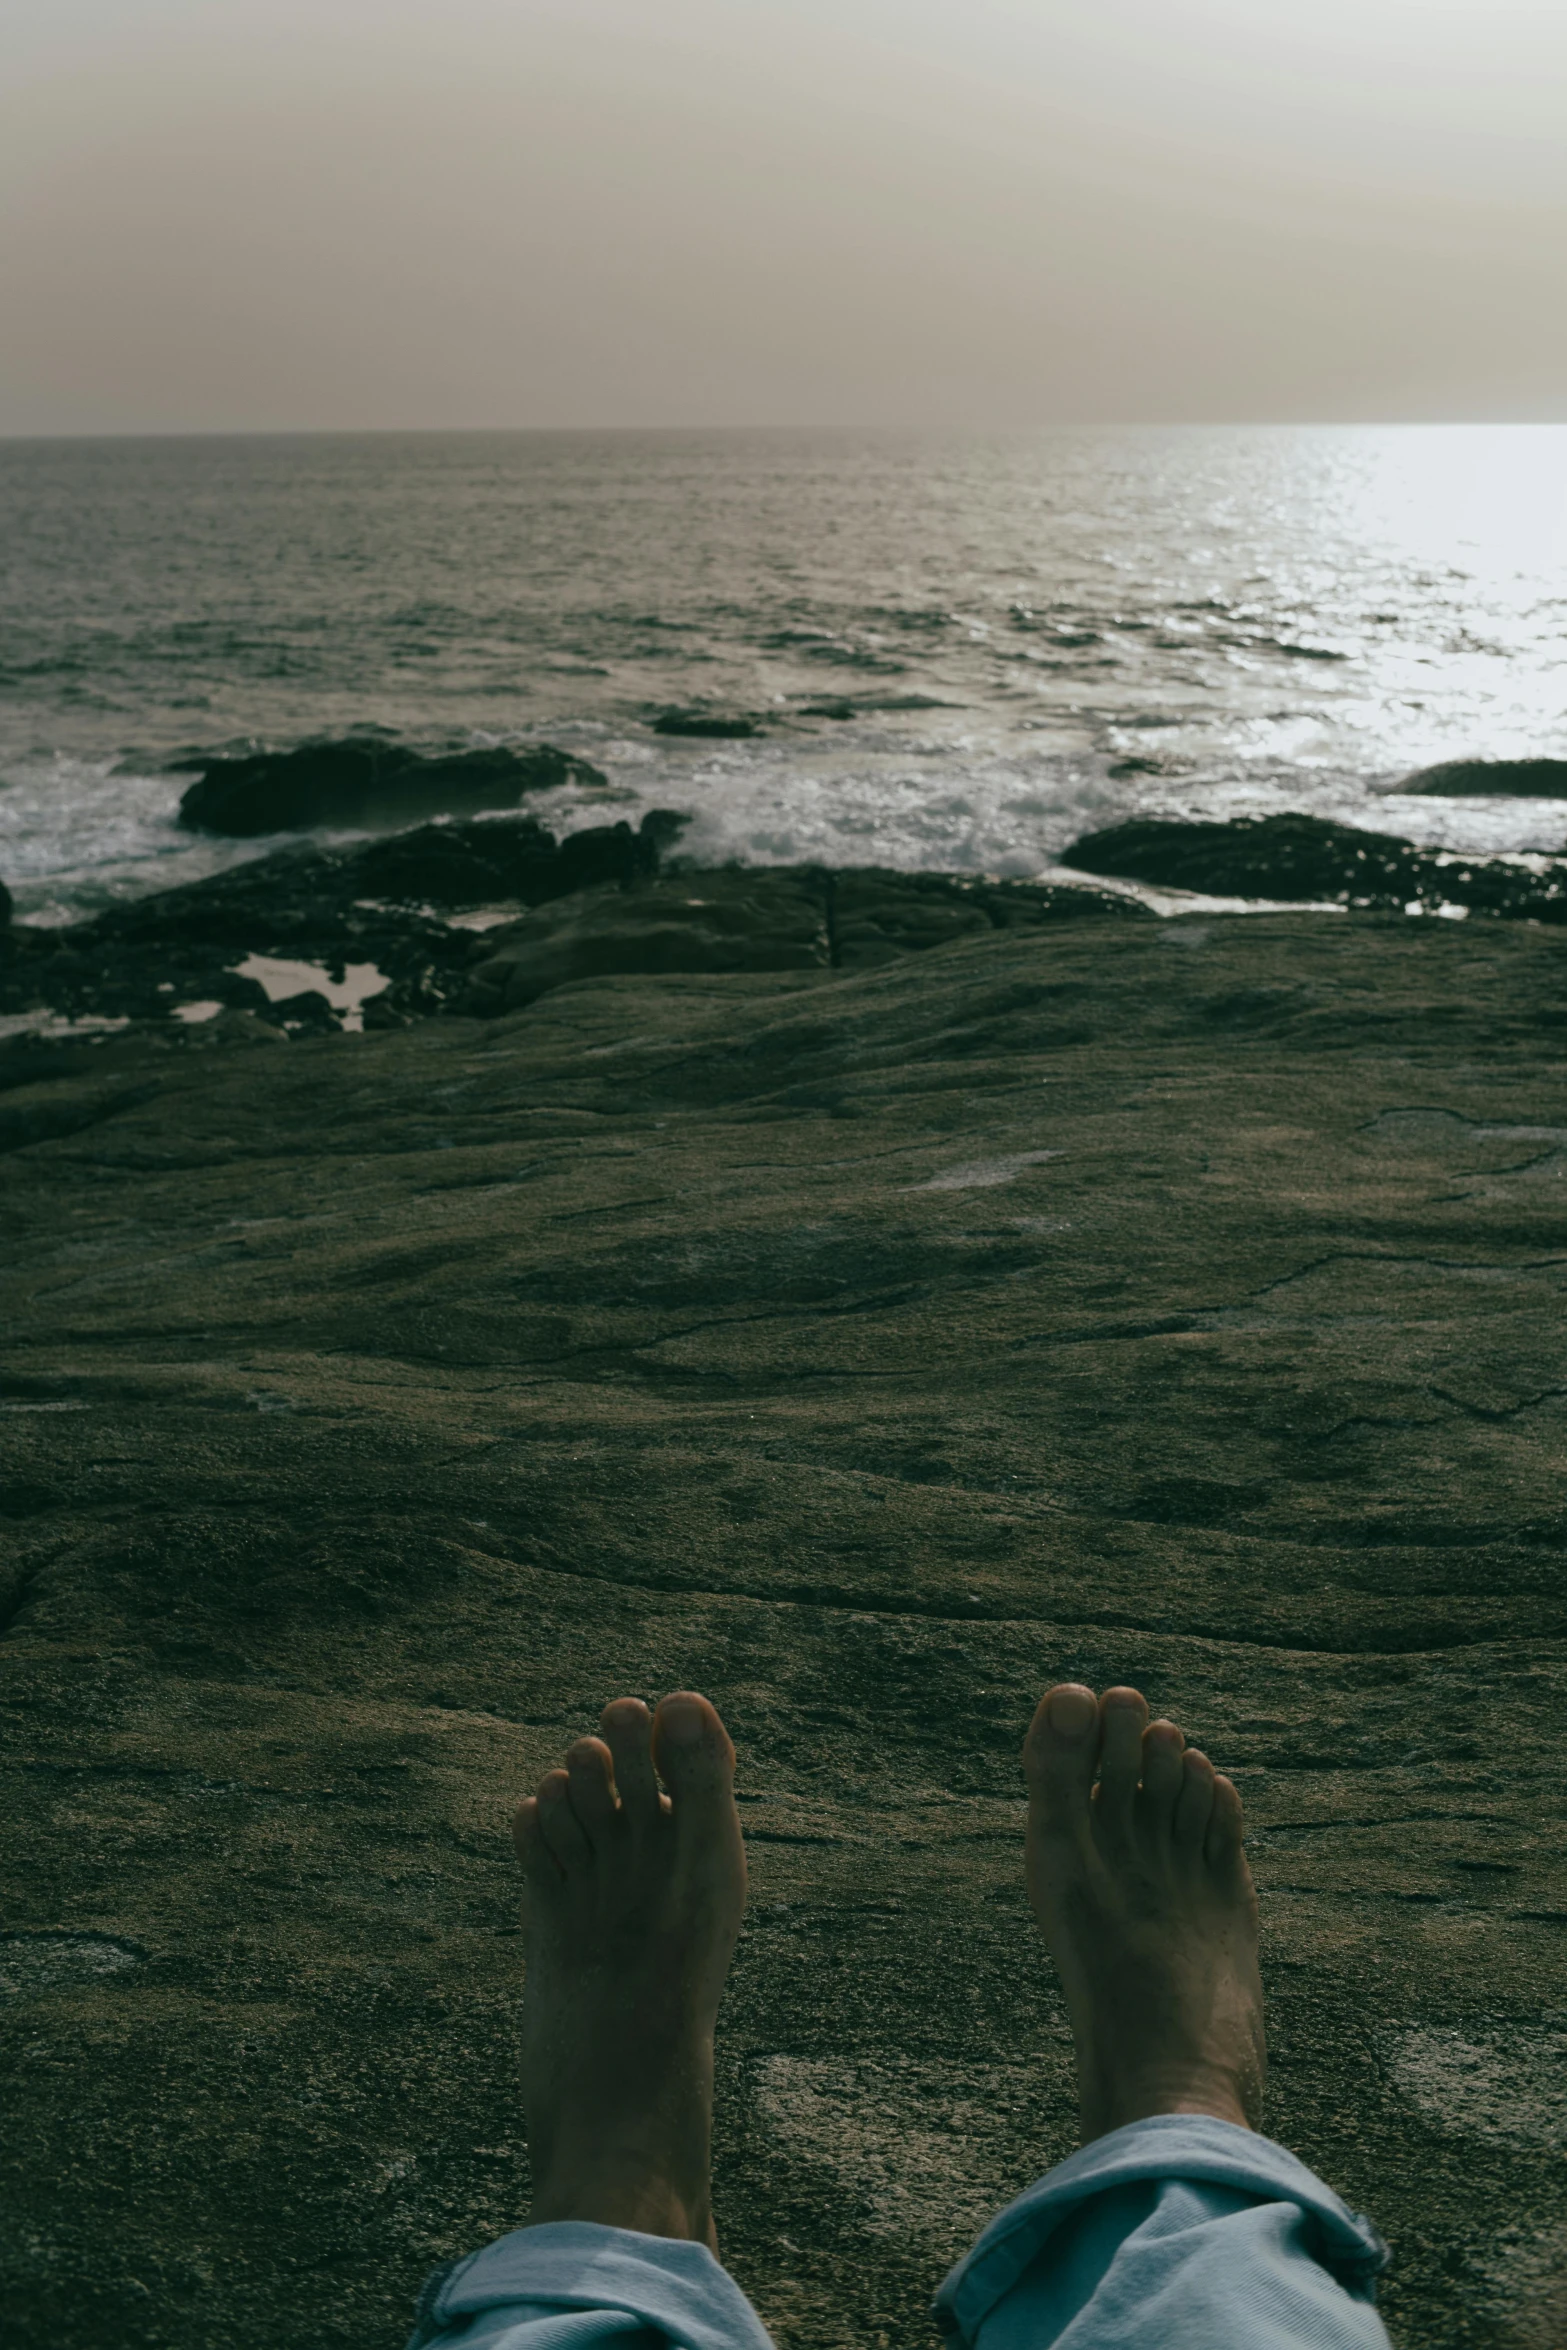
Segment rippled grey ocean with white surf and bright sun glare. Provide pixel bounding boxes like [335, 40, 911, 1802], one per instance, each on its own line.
[0, 425, 1567, 921]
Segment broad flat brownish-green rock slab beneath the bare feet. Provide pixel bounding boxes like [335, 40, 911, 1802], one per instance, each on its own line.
[0, 914, 1567, 2350]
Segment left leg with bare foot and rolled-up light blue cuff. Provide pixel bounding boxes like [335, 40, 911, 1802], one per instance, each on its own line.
[409, 1692, 771, 2350]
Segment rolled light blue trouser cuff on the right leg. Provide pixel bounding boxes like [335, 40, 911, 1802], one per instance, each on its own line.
[933, 2113, 1388, 2350]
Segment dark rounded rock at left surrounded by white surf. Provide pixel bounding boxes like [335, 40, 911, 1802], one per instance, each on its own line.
[174, 738, 604, 839]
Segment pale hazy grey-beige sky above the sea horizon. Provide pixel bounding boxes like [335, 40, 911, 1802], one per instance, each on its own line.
[0, 0, 1567, 432]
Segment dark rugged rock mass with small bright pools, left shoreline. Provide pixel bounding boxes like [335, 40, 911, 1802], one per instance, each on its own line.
[0, 808, 1132, 1032]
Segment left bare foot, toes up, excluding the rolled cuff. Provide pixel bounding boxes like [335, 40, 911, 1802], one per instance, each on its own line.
[512, 1690, 745, 2251]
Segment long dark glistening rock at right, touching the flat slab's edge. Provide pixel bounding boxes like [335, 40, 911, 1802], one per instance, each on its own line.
[1062, 815, 1567, 921]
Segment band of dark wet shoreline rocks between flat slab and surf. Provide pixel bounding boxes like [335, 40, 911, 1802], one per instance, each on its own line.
[0, 798, 1567, 1034]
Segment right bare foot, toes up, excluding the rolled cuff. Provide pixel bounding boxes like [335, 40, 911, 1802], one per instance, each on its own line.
[1022, 1683, 1264, 2143]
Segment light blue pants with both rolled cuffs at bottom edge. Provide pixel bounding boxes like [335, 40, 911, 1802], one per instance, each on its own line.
[409, 2113, 1388, 2350]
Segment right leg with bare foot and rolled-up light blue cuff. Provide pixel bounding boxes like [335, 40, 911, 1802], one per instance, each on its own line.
[935, 1683, 1386, 2350]
